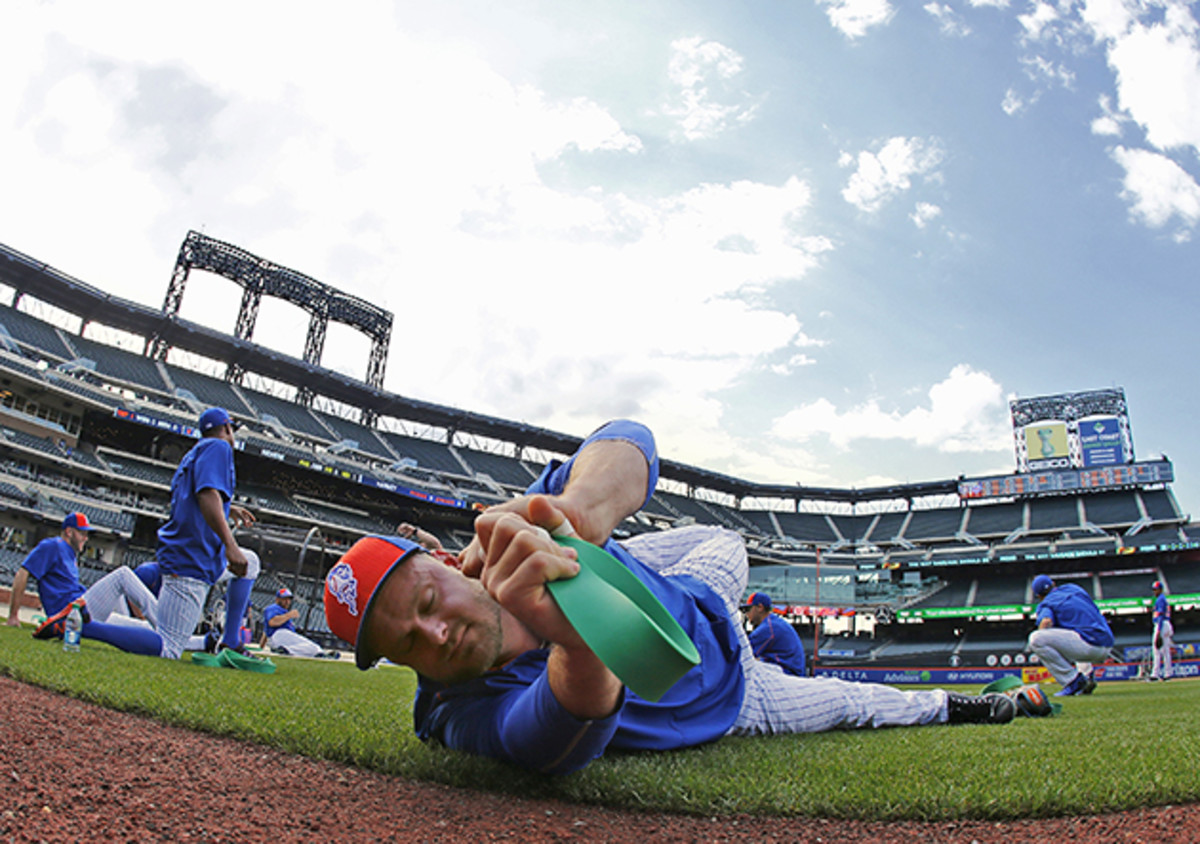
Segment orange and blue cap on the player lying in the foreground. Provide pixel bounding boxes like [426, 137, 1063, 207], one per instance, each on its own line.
[325, 537, 425, 671]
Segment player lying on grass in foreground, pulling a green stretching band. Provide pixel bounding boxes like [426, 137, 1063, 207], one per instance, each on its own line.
[325, 421, 1015, 773]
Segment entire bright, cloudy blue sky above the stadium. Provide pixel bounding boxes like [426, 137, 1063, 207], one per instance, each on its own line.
[0, 0, 1200, 513]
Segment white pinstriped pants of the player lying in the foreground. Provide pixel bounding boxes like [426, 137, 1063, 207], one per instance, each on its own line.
[623, 525, 947, 736]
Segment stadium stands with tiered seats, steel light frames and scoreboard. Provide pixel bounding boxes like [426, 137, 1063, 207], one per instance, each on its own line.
[0, 232, 1200, 682]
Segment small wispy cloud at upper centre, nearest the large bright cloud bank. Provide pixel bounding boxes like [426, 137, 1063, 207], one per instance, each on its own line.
[662, 36, 758, 140]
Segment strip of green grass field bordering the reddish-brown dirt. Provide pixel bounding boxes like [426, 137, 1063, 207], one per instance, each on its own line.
[0, 627, 1200, 820]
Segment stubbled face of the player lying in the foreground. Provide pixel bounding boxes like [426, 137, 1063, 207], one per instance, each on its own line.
[364, 553, 503, 683]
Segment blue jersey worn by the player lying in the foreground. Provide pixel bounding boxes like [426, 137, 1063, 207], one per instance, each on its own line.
[413, 421, 745, 773]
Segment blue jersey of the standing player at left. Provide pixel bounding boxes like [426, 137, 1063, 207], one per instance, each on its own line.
[158, 437, 236, 583]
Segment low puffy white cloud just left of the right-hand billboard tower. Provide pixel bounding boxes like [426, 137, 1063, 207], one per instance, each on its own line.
[772, 364, 1012, 454]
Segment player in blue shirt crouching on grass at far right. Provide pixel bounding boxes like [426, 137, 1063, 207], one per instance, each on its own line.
[1030, 574, 1114, 698]
